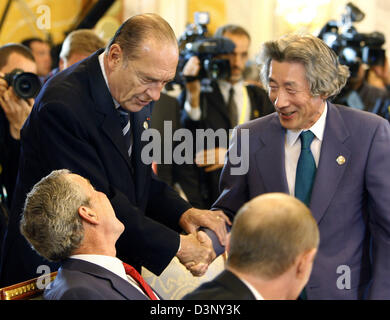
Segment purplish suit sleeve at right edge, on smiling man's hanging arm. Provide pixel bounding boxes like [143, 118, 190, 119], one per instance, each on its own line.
[366, 119, 390, 299]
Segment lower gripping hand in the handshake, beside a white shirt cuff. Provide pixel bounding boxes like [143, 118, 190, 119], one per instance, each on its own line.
[176, 231, 216, 277]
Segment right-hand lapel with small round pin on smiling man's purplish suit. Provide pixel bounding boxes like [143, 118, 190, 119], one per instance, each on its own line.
[310, 103, 351, 223]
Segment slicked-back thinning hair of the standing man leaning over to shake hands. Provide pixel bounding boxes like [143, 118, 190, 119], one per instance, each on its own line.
[106, 13, 177, 60]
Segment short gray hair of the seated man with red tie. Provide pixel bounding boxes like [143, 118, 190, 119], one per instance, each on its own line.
[20, 169, 90, 261]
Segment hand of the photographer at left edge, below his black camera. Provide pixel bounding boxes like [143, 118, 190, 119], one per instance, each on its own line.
[0, 74, 34, 140]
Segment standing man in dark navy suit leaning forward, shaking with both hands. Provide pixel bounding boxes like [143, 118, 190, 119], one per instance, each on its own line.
[0, 14, 227, 286]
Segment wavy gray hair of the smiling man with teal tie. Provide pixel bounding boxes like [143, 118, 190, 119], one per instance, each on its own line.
[258, 34, 349, 98]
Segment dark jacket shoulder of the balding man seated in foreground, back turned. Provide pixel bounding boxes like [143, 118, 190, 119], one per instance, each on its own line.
[183, 270, 255, 300]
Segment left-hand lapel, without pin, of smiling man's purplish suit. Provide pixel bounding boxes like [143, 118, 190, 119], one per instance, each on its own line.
[255, 113, 289, 193]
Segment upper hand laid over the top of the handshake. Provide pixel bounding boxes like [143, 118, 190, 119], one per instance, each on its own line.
[179, 208, 232, 246]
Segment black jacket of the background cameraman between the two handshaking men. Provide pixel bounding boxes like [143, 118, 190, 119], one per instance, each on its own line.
[179, 82, 274, 209]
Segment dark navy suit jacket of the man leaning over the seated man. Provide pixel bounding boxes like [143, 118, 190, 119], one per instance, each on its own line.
[1, 50, 191, 285]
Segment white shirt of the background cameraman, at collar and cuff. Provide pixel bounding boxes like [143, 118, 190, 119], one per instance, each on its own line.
[184, 80, 251, 122]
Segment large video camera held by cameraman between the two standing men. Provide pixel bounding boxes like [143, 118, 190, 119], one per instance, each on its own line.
[176, 12, 235, 90]
